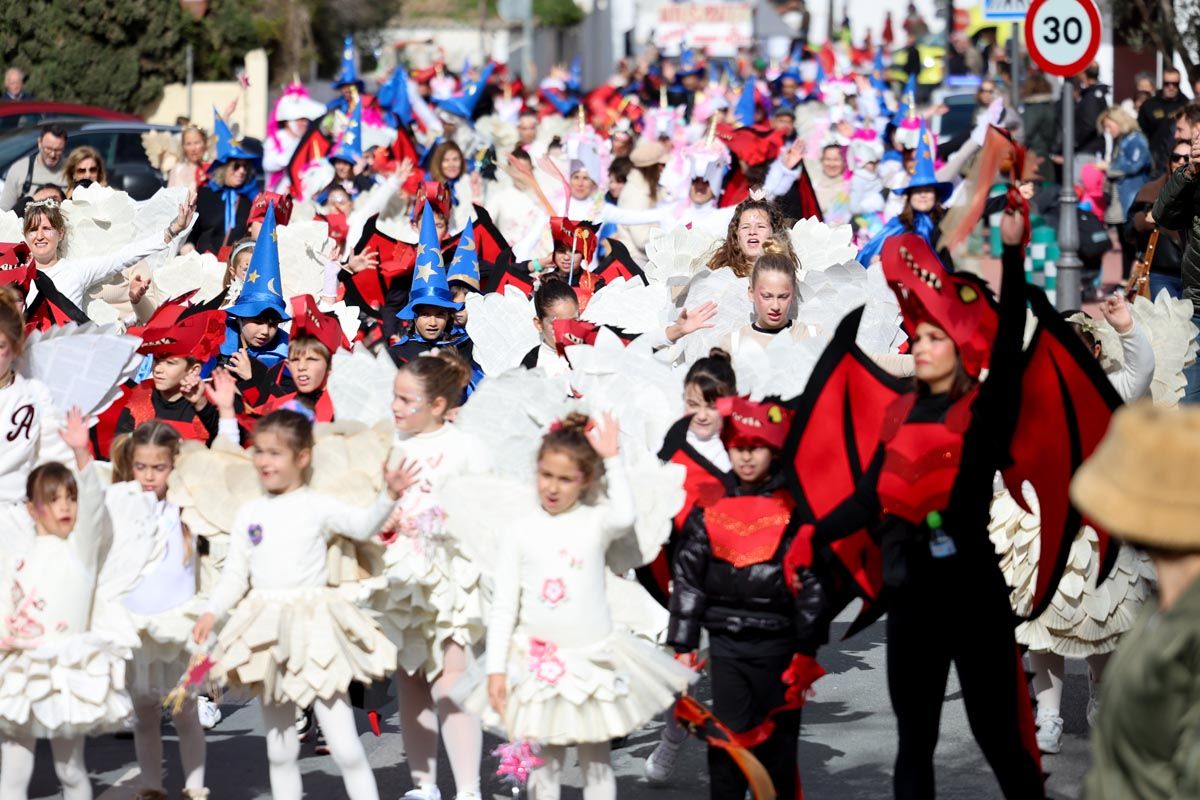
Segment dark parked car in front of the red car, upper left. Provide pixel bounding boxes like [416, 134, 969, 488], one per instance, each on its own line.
[0, 120, 263, 200]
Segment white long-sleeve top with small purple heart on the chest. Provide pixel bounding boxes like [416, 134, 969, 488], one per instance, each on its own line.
[208, 486, 392, 619]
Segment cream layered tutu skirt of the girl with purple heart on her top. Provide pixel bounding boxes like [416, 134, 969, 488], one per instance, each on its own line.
[215, 587, 396, 708]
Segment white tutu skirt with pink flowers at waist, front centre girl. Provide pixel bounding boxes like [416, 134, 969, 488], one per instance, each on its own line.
[454, 631, 696, 745]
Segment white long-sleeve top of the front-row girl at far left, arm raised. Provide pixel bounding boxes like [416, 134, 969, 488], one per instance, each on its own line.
[0, 467, 113, 648]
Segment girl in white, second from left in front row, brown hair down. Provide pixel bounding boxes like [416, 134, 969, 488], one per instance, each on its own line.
[108, 421, 209, 800]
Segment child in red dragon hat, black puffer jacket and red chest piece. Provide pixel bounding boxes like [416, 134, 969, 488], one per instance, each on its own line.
[667, 397, 823, 800]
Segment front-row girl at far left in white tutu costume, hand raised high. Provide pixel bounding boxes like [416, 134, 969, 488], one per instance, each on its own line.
[0, 411, 136, 800]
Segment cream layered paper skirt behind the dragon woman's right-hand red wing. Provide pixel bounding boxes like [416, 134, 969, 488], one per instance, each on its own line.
[990, 491, 1154, 658]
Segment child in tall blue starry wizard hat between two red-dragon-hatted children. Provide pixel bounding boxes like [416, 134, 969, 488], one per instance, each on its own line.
[218, 203, 292, 391]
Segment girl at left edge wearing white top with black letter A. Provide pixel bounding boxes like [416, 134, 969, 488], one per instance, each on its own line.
[0, 285, 71, 548]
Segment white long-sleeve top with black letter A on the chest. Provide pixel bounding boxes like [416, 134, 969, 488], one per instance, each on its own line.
[0, 374, 74, 504]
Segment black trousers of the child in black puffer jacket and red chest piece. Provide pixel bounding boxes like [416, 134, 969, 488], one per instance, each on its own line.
[708, 654, 800, 800]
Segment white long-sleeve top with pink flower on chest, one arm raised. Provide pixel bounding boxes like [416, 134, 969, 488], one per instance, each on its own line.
[487, 457, 637, 674]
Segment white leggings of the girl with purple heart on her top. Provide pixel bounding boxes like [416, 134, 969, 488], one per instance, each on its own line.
[263, 692, 379, 800]
